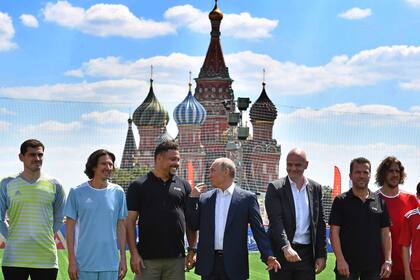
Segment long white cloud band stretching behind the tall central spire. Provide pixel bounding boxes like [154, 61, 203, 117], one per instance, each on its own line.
[0, 46, 420, 106]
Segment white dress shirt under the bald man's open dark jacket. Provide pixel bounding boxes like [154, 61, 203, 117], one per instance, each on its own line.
[289, 177, 311, 244]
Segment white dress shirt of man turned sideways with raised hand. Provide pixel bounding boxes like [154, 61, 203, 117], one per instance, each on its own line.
[214, 183, 235, 250]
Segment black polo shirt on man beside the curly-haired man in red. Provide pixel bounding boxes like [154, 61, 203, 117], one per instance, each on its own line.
[329, 189, 390, 272]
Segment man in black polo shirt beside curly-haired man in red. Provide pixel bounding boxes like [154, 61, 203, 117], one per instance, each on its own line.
[329, 158, 392, 280]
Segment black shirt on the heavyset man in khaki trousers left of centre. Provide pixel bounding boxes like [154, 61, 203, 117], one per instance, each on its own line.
[127, 172, 191, 259]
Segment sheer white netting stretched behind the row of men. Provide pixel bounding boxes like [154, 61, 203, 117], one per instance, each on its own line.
[0, 98, 420, 223]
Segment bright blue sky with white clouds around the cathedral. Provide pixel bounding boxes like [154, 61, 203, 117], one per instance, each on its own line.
[0, 0, 420, 191]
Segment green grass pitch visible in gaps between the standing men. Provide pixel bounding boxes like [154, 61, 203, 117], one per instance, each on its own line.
[0, 250, 335, 280]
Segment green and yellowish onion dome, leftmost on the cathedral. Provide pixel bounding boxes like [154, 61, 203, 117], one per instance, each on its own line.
[133, 79, 169, 127]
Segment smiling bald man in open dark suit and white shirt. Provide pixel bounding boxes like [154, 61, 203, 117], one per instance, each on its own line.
[265, 148, 327, 280]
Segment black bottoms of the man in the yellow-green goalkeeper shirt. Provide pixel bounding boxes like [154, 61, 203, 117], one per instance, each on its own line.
[2, 266, 58, 280]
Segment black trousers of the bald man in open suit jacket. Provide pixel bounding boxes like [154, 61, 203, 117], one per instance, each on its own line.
[269, 244, 315, 280]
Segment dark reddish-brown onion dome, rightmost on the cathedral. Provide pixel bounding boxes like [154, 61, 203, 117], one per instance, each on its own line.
[249, 83, 277, 122]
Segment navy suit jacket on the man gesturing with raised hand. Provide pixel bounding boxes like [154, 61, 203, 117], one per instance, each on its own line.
[186, 186, 273, 279]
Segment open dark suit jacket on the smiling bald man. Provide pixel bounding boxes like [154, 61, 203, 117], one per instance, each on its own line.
[265, 176, 327, 263]
